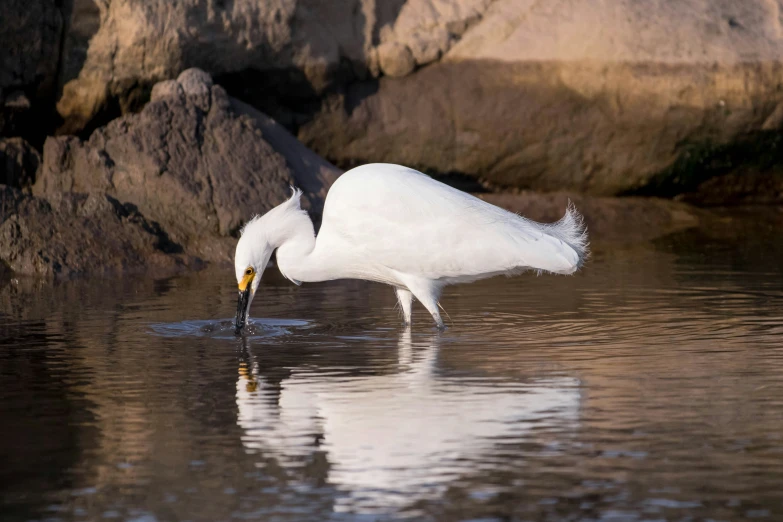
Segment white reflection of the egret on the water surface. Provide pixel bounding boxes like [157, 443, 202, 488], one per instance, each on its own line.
[236, 329, 581, 513]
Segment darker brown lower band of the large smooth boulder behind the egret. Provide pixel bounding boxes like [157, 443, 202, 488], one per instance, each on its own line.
[299, 61, 783, 195]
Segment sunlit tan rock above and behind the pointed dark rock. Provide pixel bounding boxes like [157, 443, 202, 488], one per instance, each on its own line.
[58, 0, 372, 132]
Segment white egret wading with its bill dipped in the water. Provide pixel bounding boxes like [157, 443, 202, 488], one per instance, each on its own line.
[234, 164, 588, 331]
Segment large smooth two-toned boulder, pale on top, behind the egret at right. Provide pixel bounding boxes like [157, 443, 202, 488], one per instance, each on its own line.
[298, 0, 783, 195]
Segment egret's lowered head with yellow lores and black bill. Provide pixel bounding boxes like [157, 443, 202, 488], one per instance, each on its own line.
[234, 218, 273, 333]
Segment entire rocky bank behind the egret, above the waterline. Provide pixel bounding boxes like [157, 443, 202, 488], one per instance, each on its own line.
[0, 0, 783, 277]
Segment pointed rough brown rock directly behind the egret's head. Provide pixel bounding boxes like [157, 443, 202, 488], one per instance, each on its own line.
[34, 70, 339, 262]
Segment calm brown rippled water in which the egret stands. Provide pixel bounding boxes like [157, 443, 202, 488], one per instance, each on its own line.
[0, 230, 783, 521]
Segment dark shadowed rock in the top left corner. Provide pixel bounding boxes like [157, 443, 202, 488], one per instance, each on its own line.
[0, 0, 63, 141]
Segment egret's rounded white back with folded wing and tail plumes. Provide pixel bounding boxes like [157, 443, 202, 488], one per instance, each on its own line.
[319, 164, 587, 284]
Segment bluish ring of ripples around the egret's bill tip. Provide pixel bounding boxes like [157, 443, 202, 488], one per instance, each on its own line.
[149, 318, 310, 339]
